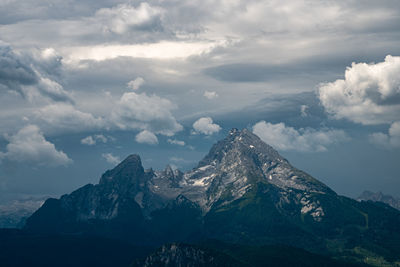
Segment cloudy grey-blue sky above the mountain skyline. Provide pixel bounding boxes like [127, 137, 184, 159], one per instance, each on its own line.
[0, 0, 400, 203]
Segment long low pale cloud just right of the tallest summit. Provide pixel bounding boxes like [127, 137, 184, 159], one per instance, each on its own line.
[253, 121, 348, 152]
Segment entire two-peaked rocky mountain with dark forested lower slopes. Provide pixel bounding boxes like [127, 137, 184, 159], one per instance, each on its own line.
[24, 129, 400, 266]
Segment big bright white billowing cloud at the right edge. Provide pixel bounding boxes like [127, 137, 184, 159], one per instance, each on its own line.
[319, 55, 400, 125]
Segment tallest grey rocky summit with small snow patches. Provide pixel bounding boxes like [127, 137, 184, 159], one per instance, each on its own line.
[191, 128, 333, 206]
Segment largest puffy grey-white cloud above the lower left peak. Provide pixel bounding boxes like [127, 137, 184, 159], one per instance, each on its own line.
[111, 92, 183, 136]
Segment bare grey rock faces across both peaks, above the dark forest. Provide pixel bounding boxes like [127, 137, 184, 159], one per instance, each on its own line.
[28, 129, 335, 226]
